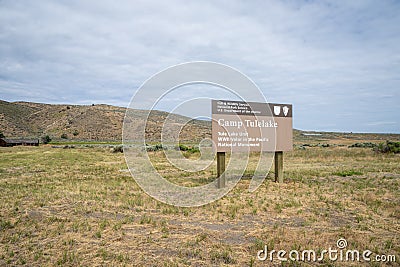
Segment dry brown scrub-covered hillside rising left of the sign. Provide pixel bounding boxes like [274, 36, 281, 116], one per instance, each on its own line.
[0, 100, 211, 141]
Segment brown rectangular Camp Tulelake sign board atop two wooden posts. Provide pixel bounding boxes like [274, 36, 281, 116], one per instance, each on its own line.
[212, 100, 293, 152]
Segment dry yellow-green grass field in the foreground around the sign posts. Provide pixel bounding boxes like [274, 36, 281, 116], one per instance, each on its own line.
[0, 142, 400, 266]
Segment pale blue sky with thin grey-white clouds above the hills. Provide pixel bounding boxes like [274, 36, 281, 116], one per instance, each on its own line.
[0, 0, 400, 133]
